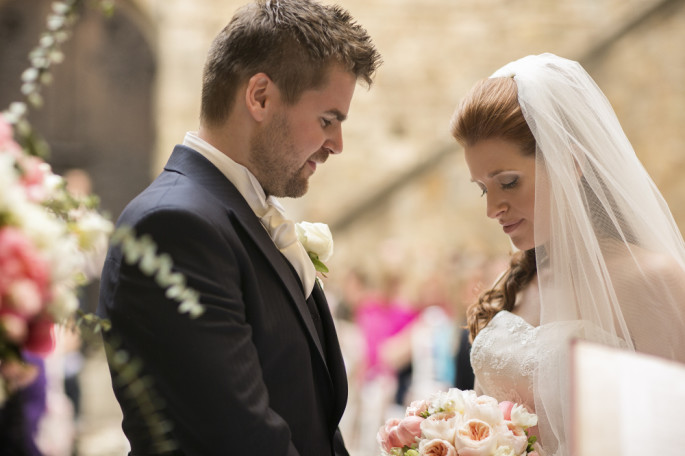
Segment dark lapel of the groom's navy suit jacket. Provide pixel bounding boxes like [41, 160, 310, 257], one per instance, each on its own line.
[165, 146, 330, 370]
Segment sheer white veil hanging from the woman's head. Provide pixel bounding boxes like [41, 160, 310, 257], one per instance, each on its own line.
[492, 54, 685, 455]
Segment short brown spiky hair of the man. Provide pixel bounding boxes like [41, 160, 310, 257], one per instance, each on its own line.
[201, 0, 381, 125]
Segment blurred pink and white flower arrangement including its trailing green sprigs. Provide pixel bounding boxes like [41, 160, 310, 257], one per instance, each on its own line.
[0, 0, 204, 453]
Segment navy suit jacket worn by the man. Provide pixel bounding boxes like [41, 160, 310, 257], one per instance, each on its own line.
[99, 146, 347, 456]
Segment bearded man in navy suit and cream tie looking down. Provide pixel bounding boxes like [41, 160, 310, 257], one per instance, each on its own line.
[100, 0, 380, 456]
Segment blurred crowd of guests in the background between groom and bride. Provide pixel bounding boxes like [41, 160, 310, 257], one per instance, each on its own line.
[325, 246, 508, 456]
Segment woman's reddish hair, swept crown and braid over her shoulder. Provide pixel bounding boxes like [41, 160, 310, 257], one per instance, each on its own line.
[451, 78, 537, 340]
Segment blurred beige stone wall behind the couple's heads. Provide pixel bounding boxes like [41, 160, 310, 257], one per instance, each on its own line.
[131, 0, 685, 294]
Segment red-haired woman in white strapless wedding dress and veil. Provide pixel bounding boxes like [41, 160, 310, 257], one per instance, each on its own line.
[452, 54, 685, 455]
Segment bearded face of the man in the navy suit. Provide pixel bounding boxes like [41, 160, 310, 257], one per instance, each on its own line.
[251, 66, 356, 198]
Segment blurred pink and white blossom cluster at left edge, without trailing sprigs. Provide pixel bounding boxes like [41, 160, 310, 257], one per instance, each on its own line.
[0, 115, 112, 381]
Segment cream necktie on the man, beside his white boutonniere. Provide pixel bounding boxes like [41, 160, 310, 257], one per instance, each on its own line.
[260, 197, 316, 298]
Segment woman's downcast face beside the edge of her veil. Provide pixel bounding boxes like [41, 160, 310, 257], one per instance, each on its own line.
[464, 139, 535, 250]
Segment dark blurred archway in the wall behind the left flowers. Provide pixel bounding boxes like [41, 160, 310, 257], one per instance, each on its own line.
[0, 0, 156, 310]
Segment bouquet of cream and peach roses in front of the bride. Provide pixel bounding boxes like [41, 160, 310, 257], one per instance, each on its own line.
[377, 388, 539, 456]
